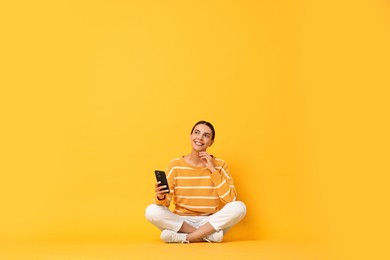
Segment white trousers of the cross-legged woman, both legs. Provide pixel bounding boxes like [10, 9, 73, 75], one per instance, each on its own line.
[145, 201, 246, 234]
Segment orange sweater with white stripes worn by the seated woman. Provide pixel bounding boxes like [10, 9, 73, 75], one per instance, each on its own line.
[154, 157, 237, 216]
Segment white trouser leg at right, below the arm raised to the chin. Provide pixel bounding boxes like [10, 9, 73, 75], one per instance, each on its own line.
[202, 201, 246, 234]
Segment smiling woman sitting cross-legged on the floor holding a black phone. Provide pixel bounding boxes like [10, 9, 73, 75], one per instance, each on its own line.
[145, 121, 246, 243]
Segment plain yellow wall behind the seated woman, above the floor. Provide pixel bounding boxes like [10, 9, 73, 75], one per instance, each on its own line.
[0, 0, 390, 259]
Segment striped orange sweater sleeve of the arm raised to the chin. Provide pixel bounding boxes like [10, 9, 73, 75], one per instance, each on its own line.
[211, 159, 237, 203]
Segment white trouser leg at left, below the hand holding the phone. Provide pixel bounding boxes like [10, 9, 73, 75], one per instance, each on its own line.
[145, 204, 184, 232]
